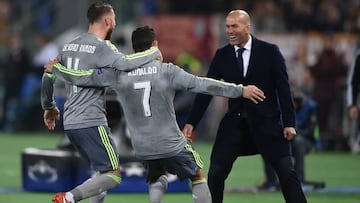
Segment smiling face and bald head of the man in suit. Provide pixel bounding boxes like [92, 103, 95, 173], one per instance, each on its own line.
[226, 10, 250, 47]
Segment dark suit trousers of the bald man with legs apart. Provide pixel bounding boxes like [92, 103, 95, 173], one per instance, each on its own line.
[208, 114, 306, 203]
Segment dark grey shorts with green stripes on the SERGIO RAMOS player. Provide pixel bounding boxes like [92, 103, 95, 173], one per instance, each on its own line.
[65, 126, 119, 172]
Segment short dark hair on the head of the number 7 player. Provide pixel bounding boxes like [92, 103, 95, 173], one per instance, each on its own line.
[131, 25, 156, 52]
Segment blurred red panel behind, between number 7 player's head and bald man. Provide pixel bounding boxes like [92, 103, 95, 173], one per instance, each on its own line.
[140, 15, 219, 62]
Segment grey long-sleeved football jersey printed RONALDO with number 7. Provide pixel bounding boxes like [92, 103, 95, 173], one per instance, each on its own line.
[53, 61, 243, 160]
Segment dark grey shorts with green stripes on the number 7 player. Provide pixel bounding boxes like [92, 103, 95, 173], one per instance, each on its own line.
[144, 143, 204, 183]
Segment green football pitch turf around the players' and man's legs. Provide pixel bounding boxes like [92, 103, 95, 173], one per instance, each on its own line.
[0, 133, 360, 203]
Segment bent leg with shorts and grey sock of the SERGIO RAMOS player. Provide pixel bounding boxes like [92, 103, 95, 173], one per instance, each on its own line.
[55, 126, 121, 203]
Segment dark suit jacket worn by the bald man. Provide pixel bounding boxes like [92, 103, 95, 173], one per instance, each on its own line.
[188, 36, 295, 159]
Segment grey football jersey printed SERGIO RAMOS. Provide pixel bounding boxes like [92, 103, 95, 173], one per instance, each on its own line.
[41, 33, 160, 130]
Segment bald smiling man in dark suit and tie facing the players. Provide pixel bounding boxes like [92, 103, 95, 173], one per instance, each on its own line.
[183, 10, 306, 203]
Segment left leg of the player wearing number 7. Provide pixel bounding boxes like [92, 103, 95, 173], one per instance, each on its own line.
[145, 160, 168, 203]
